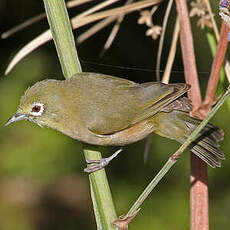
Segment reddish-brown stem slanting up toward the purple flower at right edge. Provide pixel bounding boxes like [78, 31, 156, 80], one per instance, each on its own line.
[204, 21, 229, 106]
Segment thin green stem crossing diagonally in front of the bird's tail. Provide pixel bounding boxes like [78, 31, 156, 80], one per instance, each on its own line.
[126, 87, 230, 217]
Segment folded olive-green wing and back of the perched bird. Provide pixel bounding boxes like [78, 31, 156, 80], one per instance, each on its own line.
[73, 73, 189, 135]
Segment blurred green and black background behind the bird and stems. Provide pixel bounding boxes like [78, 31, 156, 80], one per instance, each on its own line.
[0, 0, 230, 230]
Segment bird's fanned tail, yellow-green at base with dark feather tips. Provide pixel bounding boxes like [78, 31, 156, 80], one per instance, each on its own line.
[152, 109, 225, 168]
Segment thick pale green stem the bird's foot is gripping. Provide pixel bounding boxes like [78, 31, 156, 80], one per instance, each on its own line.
[44, 0, 117, 230]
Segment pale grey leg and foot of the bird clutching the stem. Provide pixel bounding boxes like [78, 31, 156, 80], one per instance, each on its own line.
[84, 148, 123, 173]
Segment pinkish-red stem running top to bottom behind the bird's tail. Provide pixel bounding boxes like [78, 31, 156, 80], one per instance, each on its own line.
[176, 0, 209, 230]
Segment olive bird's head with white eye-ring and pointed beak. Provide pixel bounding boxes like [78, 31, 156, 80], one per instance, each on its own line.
[5, 80, 60, 126]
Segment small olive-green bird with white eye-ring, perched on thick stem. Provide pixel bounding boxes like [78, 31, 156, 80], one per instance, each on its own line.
[6, 73, 225, 172]
